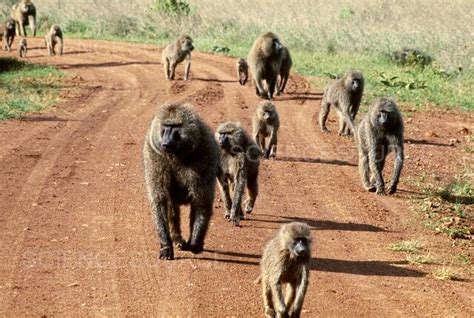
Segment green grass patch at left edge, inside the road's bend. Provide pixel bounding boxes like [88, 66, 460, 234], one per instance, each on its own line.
[0, 58, 64, 120]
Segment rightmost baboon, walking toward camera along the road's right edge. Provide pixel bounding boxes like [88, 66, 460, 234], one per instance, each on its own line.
[356, 98, 404, 195]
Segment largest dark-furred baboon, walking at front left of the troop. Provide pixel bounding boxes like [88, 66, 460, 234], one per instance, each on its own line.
[143, 103, 219, 260]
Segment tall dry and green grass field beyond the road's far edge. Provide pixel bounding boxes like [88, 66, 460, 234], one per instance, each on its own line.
[0, 0, 474, 111]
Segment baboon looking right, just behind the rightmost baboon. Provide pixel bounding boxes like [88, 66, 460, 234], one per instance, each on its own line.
[319, 71, 364, 136]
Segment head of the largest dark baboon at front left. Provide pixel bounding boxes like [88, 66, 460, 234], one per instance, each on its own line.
[152, 104, 200, 156]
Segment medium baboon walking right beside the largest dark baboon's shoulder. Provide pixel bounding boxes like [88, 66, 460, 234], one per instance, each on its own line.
[216, 122, 260, 225]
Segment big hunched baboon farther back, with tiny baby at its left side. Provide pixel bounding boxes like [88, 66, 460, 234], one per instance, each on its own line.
[247, 32, 283, 100]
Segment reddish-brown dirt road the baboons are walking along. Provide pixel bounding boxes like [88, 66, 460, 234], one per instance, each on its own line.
[0, 39, 474, 317]
